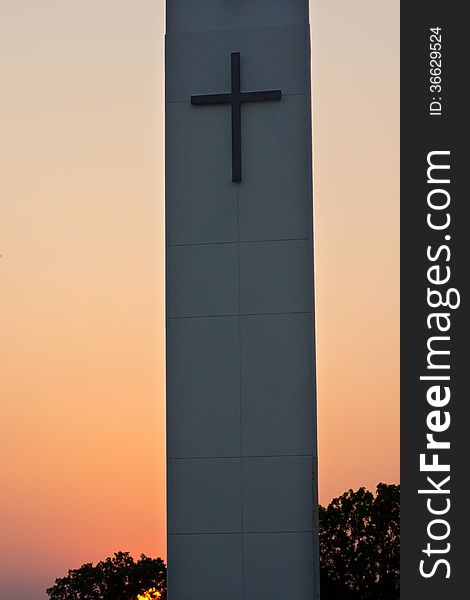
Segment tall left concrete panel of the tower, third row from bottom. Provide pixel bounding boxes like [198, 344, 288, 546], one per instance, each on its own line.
[167, 317, 240, 458]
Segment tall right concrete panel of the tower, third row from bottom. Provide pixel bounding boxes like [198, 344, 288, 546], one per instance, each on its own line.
[241, 314, 316, 456]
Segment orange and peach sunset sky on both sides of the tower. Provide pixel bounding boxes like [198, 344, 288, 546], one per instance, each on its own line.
[0, 0, 399, 600]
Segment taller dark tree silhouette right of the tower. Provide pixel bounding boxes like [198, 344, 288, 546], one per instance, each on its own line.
[320, 483, 400, 600]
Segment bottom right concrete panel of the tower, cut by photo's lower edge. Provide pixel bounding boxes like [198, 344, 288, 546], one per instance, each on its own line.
[243, 533, 318, 600]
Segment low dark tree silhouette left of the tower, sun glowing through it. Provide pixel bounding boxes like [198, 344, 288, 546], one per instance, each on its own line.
[46, 552, 166, 600]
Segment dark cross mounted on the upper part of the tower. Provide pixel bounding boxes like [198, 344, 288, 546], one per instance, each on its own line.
[191, 52, 281, 183]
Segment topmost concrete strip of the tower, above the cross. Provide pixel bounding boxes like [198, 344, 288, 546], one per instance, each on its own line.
[166, 0, 308, 33]
